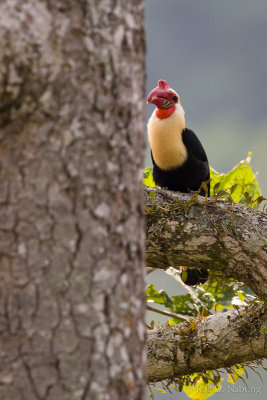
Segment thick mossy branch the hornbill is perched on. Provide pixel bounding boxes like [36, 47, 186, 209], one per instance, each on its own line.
[145, 188, 267, 300]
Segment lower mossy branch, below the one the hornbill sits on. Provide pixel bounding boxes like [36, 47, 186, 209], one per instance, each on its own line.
[147, 305, 267, 382]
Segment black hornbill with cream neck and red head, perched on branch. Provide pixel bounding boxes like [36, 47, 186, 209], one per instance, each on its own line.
[147, 80, 210, 286]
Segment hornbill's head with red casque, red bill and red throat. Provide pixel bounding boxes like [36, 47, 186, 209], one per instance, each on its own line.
[147, 80, 181, 118]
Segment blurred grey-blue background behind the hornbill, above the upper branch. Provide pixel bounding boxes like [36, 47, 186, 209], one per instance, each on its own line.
[145, 0, 267, 195]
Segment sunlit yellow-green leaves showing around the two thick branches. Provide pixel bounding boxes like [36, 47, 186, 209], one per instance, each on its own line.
[144, 153, 266, 400]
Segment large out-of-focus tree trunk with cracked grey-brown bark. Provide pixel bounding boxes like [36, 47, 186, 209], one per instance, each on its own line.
[0, 0, 145, 400]
